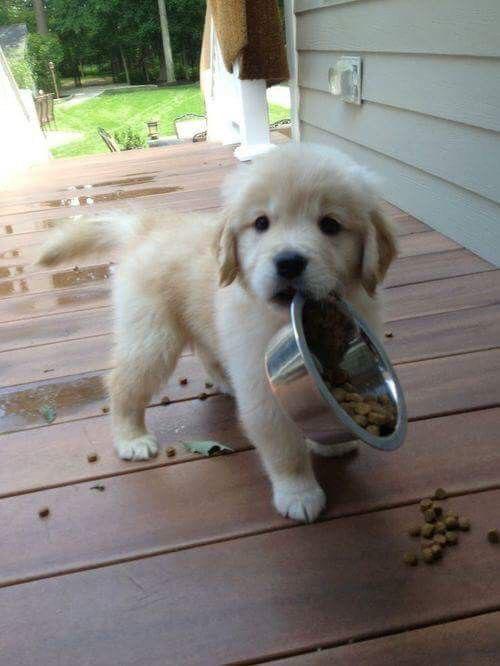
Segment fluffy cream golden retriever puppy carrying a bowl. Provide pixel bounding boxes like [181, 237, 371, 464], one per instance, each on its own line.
[39, 143, 396, 521]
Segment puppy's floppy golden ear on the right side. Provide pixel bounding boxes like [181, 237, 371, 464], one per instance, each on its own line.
[361, 208, 397, 296]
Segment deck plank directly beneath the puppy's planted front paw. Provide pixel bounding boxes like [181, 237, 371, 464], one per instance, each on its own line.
[0, 409, 500, 585]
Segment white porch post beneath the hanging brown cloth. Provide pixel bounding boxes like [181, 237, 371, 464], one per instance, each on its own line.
[203, 20, 273, 161]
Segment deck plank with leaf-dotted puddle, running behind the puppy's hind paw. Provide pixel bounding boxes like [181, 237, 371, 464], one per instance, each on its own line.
[0, 342, 500, 433]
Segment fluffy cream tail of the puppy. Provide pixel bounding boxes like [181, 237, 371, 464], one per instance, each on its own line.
[36, 215, 139, 266]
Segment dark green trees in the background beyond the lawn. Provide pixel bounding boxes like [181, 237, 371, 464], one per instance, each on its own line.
[0, 0, 206, 89]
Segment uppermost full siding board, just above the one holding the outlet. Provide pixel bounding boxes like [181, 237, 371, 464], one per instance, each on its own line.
[297, 0, 500, 57]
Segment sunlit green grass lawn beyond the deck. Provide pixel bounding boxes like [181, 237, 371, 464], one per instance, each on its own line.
[52, 84, 290, 157]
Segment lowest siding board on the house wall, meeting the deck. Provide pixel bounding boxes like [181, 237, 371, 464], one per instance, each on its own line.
[301, 122, 500, 265]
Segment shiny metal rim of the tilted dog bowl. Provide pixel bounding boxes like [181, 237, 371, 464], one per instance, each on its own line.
[290, 292, 408, 451]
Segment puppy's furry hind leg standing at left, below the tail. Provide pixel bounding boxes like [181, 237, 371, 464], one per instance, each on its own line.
[109, 309, 184, 460]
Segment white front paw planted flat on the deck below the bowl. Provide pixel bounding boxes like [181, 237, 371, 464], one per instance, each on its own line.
[274, 481, 326, 523]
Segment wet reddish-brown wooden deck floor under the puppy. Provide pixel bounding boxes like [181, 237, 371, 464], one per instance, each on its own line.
[0, 144, 500, 666]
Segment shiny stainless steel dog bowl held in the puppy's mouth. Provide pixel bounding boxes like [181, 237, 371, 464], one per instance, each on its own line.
[265, 293, 407, 451]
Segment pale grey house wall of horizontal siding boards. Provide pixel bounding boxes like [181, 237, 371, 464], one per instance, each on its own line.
[294, 0, 500, 265]
